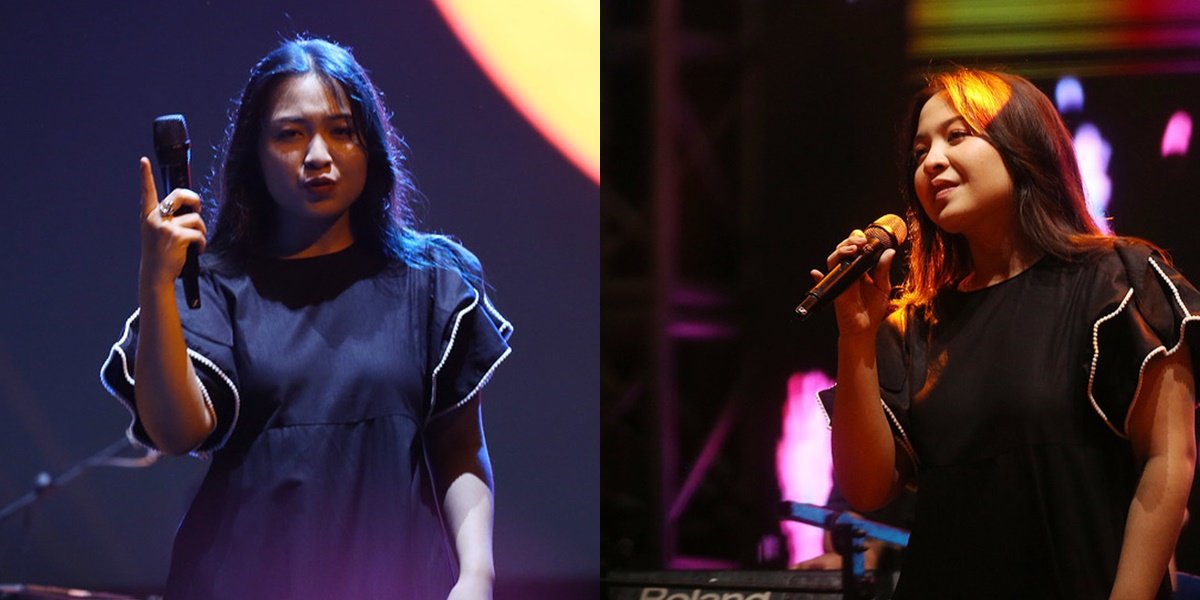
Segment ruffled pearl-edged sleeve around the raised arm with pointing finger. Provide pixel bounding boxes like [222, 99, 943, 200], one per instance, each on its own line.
[100, 257, 240, 457]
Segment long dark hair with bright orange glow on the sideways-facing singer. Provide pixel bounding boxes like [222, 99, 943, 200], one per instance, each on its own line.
[899, 68, 1116, 316]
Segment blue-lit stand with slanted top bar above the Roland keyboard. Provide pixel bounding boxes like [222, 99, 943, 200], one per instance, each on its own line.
[780, 500, 908, 600]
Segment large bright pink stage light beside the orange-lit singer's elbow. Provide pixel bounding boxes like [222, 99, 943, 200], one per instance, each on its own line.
[775, 371, 834, 564]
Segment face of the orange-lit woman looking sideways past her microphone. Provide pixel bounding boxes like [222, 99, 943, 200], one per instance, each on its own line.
[912, 94, 1015, 236]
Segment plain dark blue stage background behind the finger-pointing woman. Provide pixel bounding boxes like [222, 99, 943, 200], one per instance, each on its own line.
[0, 0, 599, 598]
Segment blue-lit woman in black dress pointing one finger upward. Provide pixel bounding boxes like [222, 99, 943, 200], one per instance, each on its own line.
[102, 40, 511, 599]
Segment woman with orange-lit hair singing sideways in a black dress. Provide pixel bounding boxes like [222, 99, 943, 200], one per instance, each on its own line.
[809, 68, 1200, 600]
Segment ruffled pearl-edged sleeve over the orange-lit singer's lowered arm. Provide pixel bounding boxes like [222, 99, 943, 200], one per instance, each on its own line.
[1087, 241, 1200, 438]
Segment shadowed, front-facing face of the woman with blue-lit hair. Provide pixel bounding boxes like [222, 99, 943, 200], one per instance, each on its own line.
[258, 74, 367, 241]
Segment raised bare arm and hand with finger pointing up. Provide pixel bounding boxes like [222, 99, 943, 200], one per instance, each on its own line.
[134, 158, 216, 454]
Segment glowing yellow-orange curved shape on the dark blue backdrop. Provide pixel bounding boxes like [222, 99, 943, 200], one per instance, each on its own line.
[433, 0, 600, 182]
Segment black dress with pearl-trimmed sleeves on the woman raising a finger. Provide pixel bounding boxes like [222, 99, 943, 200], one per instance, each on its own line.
[101, 239, 512, 600]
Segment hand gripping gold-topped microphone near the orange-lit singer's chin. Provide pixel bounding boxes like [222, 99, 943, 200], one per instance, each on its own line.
[796, 215, 908, 335]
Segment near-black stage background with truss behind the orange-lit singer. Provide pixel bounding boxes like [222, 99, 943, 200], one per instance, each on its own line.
[601, 0, 1200, 572]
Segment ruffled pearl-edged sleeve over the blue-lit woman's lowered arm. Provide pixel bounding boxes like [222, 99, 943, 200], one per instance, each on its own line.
[427, 239, 512, 419]
